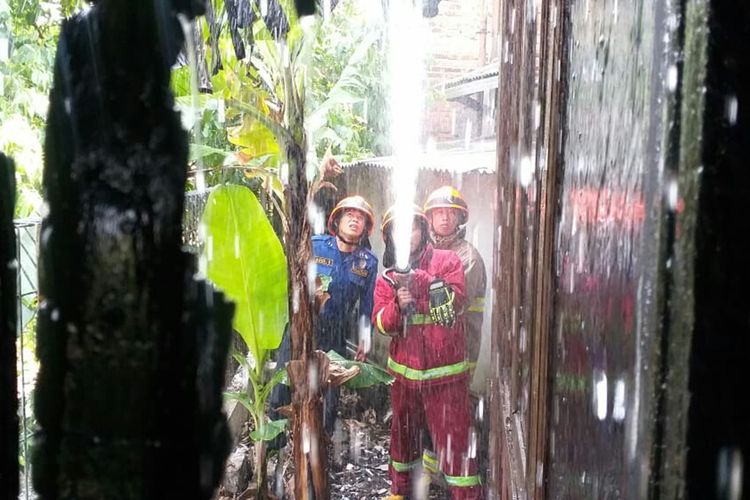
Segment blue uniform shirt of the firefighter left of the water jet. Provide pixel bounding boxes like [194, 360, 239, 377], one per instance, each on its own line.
[312, 235, 378, 355]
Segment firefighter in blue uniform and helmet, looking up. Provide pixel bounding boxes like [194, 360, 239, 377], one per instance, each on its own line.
[269, 196, 378, 448]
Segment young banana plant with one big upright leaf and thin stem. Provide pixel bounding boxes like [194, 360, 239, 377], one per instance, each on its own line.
[202, 185, 288, 498]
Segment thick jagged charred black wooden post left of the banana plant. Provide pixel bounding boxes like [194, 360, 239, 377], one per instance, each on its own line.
[33, 0, 232, 499]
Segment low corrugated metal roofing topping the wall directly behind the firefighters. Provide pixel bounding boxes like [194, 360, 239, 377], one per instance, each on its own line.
[342, 149, 497, 174]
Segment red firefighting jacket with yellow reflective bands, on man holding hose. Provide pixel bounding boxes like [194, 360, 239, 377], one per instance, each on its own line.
[372, 245, 469, 385]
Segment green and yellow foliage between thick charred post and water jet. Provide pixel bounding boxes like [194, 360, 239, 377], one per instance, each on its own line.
[173, 0, 386, 193]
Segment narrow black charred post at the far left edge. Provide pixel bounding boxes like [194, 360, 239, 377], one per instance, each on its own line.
[0, 153, 18, 498]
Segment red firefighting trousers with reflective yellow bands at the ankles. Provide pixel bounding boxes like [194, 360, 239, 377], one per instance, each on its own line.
[389, 377, 483, 500]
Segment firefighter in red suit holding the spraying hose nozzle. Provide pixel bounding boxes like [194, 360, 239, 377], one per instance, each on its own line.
[372, 206, 482, 500]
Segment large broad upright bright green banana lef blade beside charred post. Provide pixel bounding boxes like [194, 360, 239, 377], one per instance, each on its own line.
[203, 185, 288, 366]
